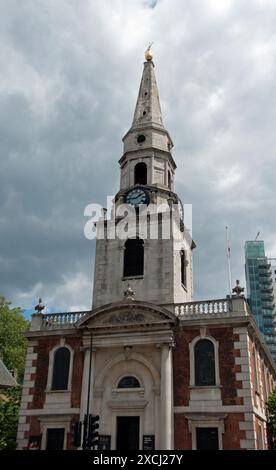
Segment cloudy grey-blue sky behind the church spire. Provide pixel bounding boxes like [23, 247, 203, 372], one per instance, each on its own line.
[0, 0, 276, 311]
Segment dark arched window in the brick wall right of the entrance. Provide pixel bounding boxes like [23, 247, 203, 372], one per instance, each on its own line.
[194, 339, 216, 386]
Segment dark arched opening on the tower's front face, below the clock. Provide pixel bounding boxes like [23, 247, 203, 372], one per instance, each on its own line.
[124, 238, 144, 276]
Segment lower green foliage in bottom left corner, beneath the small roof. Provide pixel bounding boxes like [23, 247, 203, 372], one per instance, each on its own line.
[0, 386, 22, 450]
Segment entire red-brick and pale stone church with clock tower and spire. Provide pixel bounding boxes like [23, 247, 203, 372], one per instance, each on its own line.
[17, 49, 276, 451]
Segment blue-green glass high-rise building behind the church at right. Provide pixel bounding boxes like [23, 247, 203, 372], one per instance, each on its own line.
[245, 240, 276, 362]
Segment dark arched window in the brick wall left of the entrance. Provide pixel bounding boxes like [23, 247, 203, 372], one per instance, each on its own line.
[52, 347, 70, 390]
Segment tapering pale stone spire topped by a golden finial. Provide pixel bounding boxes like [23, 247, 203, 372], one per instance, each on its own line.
[132, 46, 164, 129]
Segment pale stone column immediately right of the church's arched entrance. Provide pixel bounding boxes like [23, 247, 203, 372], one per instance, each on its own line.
[160, 344, 173, 450]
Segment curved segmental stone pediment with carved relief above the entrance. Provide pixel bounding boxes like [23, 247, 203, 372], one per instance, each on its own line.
[76, 301, 176, 328]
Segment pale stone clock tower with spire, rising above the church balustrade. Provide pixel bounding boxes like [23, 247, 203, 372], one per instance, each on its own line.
[93, 49, 195, 307]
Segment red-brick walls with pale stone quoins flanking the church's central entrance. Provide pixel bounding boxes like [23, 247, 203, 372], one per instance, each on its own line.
[18, 306, 275, 450]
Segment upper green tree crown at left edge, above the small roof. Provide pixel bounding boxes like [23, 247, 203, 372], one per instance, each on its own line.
[0, 296, 29, 383]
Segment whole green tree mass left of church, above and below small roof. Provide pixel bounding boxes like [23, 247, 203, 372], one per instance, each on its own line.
[0, 296, 29, 450]
